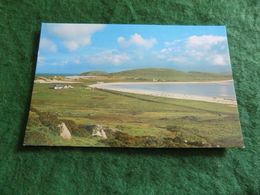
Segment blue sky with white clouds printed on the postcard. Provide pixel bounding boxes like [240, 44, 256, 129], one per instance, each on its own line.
[36, 23, 231, 74]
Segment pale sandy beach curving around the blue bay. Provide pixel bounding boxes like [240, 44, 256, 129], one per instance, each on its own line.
[89, 80, 237, 105]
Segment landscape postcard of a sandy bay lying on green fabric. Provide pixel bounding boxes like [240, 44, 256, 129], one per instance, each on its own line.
[24, 23, 244, 148]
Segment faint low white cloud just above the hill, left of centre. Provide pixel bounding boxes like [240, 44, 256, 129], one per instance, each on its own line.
[87, 50, 130, 65]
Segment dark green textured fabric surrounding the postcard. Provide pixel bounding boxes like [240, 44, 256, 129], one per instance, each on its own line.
[0, 0, 260, 195]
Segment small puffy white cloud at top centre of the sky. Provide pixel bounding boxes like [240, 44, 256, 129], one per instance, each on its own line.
[117, 33, 157, 49]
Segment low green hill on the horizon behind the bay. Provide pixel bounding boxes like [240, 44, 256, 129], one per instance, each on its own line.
[81, 68, 232, 81]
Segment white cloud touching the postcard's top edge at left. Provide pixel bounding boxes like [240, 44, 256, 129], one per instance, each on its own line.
[49, 24, 105, 51]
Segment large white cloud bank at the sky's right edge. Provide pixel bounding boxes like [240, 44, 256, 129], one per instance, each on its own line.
[157, 35, 230, 66]
